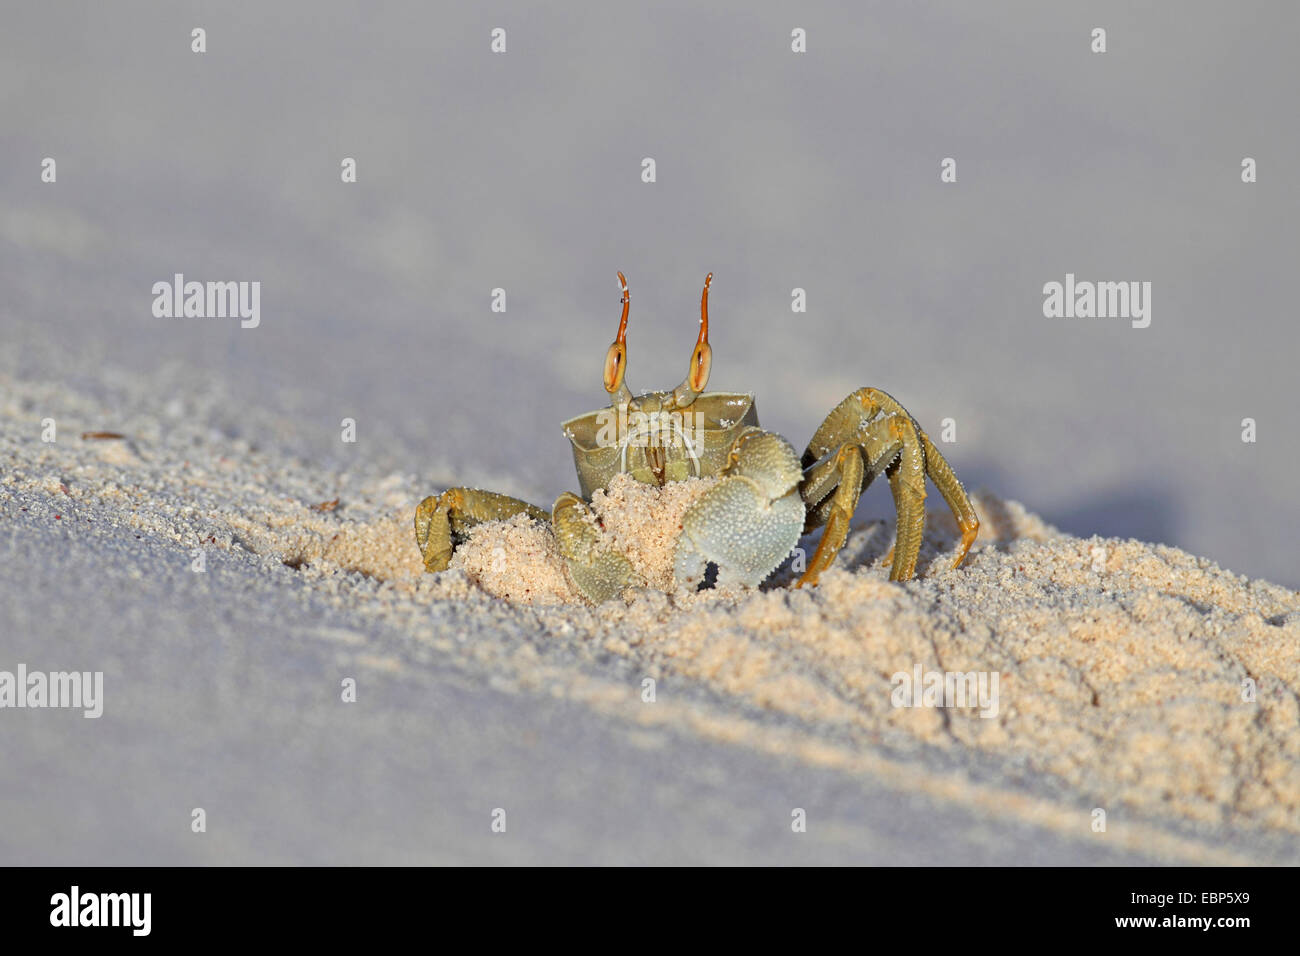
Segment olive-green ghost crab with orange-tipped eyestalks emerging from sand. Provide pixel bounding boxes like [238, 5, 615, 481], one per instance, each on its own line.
[415, 272, 979, 604]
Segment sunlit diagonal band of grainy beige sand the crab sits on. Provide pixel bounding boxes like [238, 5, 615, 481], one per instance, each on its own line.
[0, 369, 1300, 862]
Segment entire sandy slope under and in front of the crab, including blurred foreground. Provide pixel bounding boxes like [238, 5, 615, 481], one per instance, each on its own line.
[0, 358, 1300, 864]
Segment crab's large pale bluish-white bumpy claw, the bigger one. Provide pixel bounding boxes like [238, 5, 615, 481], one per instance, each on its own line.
[673, 428, 805, 587]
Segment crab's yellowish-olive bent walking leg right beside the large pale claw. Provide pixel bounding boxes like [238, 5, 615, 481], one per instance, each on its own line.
[794, 415, 906, 588]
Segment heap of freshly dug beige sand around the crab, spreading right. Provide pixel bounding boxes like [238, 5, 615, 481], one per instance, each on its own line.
[428, 480, 1300, 831]
